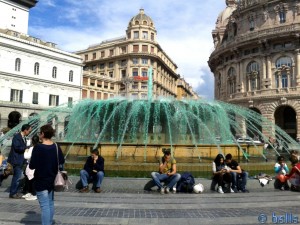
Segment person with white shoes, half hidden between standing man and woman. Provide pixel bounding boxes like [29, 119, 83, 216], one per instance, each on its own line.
[22, 135, 39, 200]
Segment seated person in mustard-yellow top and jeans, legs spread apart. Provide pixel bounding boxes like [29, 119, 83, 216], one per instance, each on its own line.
[151, 148, 180, 194]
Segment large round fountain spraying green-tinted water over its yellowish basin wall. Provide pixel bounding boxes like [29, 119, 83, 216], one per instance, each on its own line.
[0, 68, 299, 177]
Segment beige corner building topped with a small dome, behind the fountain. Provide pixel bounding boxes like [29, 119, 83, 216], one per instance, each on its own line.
[77, 9, 197, 99]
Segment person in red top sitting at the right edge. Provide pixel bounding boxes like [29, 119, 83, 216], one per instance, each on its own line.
[285, 155, 300, 191]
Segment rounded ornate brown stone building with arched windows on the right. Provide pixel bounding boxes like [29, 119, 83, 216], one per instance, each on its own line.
[208, 0, 300, 139]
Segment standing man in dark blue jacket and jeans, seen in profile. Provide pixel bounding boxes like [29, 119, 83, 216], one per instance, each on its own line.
[7, 124, 31, 199]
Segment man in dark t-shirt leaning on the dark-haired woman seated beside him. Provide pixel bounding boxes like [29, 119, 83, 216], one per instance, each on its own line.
[225, 153, 249, 193]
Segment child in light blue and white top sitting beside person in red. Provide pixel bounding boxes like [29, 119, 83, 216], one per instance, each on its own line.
[274, 156, 290, 191]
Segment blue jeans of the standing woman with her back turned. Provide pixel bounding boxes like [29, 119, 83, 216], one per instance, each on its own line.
[36, 190, 54, 225]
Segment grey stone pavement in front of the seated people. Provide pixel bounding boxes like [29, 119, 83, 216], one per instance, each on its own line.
[0, 176, 300, 225]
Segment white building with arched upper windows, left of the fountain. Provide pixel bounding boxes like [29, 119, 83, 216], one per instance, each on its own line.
[0, 0, 82, 132]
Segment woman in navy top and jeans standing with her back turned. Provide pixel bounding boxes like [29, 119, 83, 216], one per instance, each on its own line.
[29, 124, 65, 225]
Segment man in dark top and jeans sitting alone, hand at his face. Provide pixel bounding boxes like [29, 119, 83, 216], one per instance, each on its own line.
[79, 149, 104, 193]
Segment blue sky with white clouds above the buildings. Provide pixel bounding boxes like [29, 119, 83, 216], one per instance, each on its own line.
[28, 0, 226, 100]
